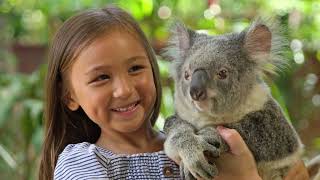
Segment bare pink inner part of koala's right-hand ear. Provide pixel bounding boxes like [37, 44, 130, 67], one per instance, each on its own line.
[244, 23, 272, 60]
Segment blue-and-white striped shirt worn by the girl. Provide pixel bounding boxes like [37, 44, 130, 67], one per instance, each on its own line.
[54, 142, 181, 180]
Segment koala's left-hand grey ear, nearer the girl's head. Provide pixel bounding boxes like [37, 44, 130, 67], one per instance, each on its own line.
[162, 21, 195, 61]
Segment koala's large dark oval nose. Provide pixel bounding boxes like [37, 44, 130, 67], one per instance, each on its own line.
[190, 69, 209, 101]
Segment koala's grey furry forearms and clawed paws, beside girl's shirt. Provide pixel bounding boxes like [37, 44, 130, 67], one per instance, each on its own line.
[164, 115, 220, 179]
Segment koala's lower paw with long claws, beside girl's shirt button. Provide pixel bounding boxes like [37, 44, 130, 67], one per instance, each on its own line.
[180, 149, 218, 180]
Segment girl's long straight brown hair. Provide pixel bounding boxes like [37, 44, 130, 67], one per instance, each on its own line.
[39, 6, 161, 180]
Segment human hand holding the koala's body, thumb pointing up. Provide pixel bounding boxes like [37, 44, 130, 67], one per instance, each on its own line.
[214, 126, 261, 180]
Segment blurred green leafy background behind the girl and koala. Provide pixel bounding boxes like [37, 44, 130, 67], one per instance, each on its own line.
[0, 0, 320, 179]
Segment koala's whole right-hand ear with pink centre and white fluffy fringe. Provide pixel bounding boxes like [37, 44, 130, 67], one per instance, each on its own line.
[241, 18, 289, 74]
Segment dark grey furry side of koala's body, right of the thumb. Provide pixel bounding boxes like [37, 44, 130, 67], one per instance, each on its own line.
[227, 99, 300, 168]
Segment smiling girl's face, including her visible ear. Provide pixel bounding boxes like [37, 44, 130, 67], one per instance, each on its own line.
[68, 31, 156, 132]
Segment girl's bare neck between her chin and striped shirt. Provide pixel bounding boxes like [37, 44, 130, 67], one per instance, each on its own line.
[96, 126, 165, 154]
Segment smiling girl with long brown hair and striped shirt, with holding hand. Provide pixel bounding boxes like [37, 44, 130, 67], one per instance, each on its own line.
[39, 4, 308, 180]
